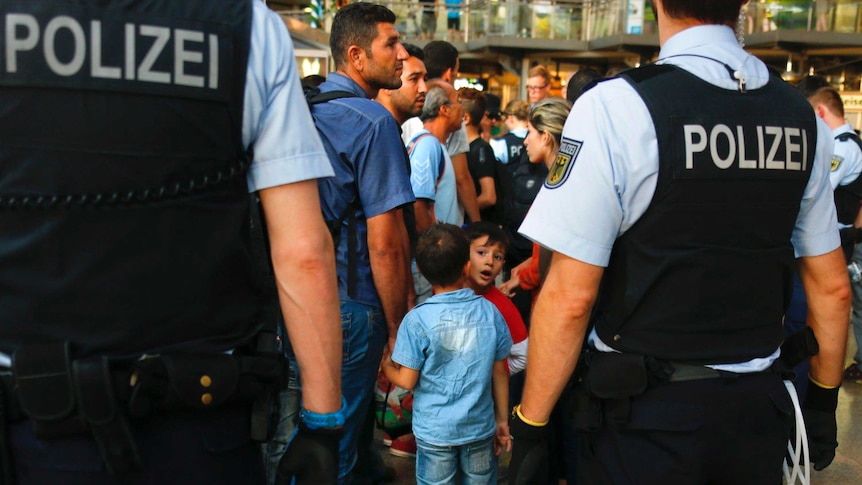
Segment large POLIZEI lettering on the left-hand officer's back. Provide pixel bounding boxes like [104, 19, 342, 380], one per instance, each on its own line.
[0, 2, 232, 97]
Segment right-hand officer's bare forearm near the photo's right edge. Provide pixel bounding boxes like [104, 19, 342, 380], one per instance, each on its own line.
[799, 248, 851, 386]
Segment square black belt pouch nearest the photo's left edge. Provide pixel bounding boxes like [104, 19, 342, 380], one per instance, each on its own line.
[12, 342, 75, 430]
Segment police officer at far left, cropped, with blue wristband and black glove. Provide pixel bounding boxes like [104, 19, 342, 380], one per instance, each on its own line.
[0, 0, 343, 485]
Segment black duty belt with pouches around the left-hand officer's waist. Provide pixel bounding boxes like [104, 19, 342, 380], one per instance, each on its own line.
[7, 332, 284, 473]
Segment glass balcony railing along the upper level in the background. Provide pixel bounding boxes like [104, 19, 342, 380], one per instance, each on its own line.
[281, 0, 862, 42]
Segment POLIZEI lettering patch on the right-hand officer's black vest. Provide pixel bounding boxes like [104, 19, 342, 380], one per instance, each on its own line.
[674, 120, 814, 178]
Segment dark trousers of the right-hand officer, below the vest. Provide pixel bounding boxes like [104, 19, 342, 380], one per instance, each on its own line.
[578, 372, 793, 485]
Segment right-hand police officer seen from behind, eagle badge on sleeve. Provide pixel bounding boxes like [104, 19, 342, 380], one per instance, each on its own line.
[509, 0, 850, 484]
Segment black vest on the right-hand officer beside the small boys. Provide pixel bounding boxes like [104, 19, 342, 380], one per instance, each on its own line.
[593, 65, 817, 364]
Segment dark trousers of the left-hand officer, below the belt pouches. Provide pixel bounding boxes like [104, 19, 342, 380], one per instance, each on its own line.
[10, 405, 264, 485]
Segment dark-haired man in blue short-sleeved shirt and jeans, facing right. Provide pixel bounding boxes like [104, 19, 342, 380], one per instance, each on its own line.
[304, 3, 414, 483]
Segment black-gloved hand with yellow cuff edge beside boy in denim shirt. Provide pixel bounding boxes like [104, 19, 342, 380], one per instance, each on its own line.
[509, 406, 548, 485]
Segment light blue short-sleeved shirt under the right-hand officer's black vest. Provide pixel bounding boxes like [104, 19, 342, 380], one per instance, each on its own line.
[520, 25, 840, 372]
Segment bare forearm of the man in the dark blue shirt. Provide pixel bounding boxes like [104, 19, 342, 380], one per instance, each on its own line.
[368, 210, 418, 346]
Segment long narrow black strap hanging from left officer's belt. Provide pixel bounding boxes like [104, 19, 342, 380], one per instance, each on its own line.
[72, 356, 141, 473]
